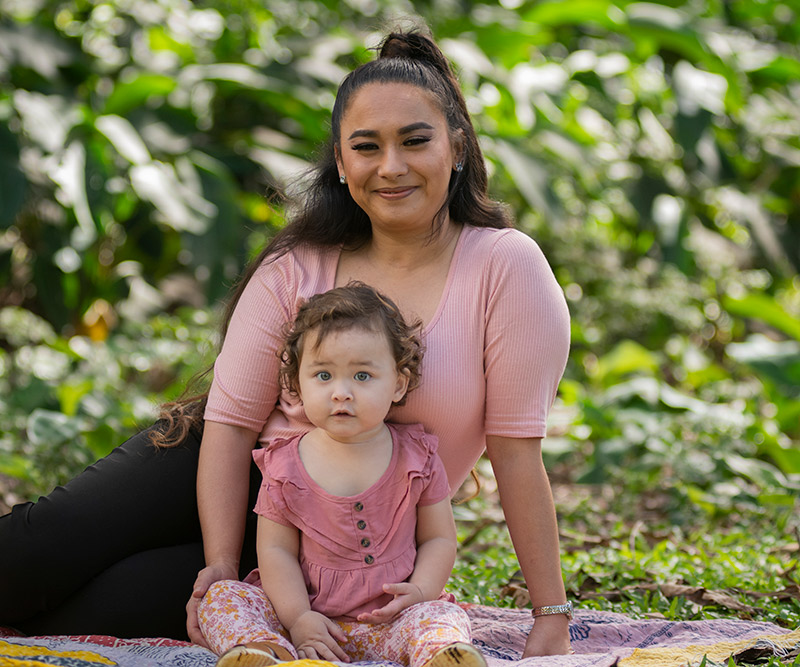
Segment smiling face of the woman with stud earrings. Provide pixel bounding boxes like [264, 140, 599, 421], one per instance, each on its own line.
[336, 83, 461, 234]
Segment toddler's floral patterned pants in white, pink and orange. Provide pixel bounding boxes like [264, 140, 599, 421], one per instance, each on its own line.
[198, 581, 470, 667]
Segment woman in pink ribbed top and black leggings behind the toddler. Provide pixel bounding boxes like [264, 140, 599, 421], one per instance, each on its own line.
[0, 26, 569, 656]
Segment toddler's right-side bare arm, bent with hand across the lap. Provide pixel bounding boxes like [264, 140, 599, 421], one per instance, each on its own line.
[358, 498, 458, 623]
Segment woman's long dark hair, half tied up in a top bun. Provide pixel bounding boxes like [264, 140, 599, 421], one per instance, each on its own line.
[151, 24, 511, 447]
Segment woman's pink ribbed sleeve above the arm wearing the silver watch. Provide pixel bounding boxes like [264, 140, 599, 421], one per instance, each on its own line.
[484, 230, 570, 438]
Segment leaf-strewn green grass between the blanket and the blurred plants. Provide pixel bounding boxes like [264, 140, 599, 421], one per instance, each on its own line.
[451, 462, 800, 667]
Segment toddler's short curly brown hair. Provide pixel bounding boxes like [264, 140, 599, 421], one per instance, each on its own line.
[278, 281, 423, 405]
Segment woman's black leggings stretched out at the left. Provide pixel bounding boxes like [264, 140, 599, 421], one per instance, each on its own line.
[0, 427, 260, 639]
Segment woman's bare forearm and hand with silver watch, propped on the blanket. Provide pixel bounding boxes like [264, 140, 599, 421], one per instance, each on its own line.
[486, 436, 569, 657]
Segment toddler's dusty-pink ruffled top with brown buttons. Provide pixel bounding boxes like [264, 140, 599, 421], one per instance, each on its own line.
[253, 424, 450, 618]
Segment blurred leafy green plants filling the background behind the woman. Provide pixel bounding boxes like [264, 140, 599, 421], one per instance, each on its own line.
[0, 0, 800, 640]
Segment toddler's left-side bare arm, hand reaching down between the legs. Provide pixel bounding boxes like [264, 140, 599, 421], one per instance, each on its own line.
[257, 516, 349, 662]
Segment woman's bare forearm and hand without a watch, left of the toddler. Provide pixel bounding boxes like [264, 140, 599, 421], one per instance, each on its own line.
[186, 421, 258, 646]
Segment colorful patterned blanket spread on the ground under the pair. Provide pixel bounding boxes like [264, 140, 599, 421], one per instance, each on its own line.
[0, 605, 800, 667]
